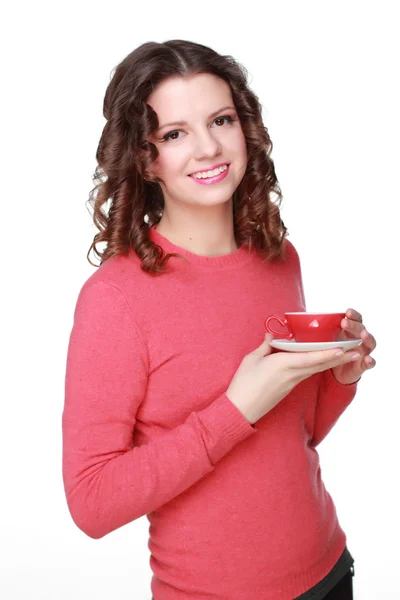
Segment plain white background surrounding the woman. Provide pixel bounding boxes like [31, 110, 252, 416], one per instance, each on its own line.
[0, 0, 400, 600]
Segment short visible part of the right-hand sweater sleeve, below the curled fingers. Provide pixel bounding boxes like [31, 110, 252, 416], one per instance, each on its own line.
[311, 369, 359, 448]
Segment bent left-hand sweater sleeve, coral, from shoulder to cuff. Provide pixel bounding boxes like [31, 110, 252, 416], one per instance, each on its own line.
[62, 281, 256, 539]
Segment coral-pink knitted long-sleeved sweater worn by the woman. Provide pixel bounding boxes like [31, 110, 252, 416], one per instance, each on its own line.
[62, 229, 357, 600]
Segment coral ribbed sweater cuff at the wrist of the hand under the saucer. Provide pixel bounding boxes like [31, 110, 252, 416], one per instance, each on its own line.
[195, 392, 257, 465]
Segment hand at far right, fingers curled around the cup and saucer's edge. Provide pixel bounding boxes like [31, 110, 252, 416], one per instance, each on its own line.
[332, 308, 376, 385]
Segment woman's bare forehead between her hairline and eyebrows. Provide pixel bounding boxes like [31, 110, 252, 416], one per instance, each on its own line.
[147, 73, 233, 121]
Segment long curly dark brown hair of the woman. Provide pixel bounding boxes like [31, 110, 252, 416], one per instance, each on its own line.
[87, 40, 287, 275]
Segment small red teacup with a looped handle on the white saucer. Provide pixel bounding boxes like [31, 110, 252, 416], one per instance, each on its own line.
[264, 312, 346, 342]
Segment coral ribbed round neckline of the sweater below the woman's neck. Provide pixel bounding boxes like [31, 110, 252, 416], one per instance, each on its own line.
[149, 223, 252, 269]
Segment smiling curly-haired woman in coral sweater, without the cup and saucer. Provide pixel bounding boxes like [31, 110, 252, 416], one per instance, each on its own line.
[63, 40, 376, 600]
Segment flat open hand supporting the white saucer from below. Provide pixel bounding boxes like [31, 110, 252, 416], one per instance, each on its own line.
[226, 333, 359, 425]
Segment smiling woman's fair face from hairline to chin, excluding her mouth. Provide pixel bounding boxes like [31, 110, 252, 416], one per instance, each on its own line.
[147, 74, 247, 206]
